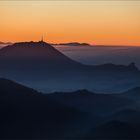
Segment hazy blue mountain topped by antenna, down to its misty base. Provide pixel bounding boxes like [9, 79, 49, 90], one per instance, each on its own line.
[0, 41, 140, 93]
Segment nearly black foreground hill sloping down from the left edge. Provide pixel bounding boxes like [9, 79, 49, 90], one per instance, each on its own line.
[0, 78, 86, 139]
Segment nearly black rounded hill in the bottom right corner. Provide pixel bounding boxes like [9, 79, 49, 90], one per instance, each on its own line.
[89, 120, 139, 140]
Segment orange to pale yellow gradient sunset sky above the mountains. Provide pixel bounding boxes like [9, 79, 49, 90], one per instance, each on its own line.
[0, 0, 140, 46]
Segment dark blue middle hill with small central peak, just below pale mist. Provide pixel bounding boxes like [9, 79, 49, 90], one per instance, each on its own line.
[47, 90, 131, 117]
